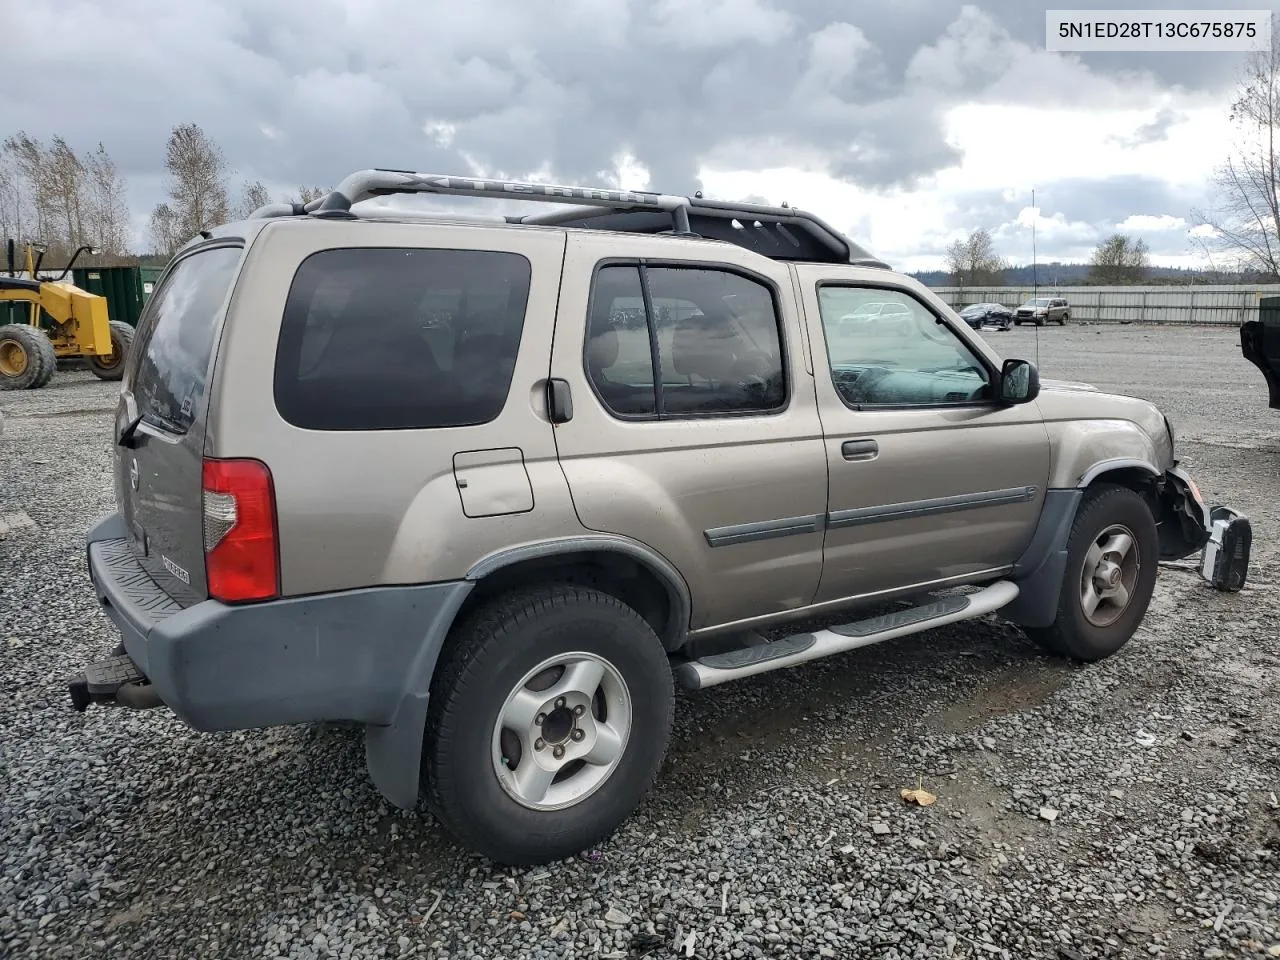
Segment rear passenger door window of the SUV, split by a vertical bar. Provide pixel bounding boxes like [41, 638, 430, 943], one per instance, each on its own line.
[585, 265, 787, 417]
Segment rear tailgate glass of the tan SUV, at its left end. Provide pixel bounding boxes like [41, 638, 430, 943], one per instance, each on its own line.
[133, 246, 241, 434]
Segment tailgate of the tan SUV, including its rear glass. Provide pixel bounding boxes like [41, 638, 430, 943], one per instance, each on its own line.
[115, 241, 243, 605]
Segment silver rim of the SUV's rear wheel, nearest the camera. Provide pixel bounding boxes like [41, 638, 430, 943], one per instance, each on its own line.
[492, 653, 631, 810]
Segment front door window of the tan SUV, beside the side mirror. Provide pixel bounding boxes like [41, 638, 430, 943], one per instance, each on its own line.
[818, 284, 992, 407]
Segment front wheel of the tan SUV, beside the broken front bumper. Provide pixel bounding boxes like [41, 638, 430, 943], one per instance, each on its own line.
[1025, 484, 1160, 662]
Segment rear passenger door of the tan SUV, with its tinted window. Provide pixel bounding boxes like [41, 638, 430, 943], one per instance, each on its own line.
[552, 233, 827, 628]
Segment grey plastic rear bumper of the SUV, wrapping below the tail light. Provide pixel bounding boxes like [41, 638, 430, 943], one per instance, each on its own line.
[73, 515, 471, 731]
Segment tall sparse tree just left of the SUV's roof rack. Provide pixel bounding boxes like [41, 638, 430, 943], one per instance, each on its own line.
[151, 123, 230, 255]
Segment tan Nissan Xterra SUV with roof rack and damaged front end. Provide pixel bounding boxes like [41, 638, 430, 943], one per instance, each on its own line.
[70, 170, 1251, 863]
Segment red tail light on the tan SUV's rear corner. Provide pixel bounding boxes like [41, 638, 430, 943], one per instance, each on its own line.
[202, 460, 280, 603]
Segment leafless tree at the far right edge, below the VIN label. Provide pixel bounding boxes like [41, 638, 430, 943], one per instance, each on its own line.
[1193, 15, 1280, 278]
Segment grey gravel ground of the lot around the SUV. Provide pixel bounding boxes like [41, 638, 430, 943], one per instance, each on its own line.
[0, 325, 1280, 960]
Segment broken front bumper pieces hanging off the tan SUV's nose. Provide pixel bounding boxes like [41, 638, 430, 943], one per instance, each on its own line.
[1157, 463, 1253, 593]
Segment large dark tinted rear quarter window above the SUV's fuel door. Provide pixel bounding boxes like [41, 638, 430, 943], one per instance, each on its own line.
[275, 247, 531, 430]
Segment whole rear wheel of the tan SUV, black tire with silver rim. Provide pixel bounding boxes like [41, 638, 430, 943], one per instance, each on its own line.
[422, 586, 675, 865]
